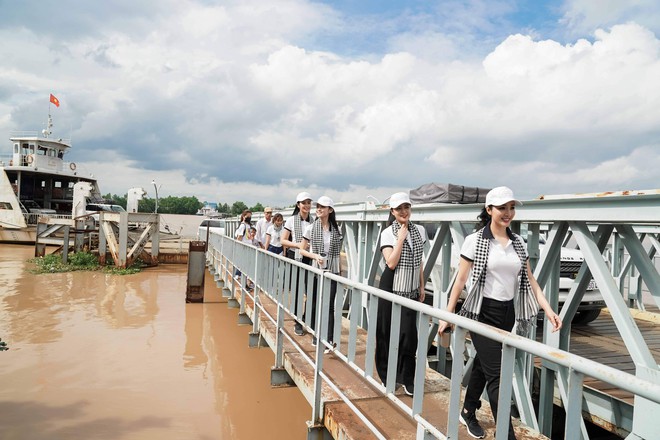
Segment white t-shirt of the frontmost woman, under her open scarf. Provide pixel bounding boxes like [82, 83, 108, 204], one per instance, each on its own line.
[461, 232, 521, 301]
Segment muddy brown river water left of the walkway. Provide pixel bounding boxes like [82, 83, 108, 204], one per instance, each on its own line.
[0, 244, 311, 440]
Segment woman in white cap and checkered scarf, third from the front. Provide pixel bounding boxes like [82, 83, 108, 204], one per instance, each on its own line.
[300, 196, 344, 350]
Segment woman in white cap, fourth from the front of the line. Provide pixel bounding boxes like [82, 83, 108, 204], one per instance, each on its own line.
[280, 191, 313, 336]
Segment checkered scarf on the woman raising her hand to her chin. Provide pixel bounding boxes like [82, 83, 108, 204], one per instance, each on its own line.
[392, 222, 424, 299]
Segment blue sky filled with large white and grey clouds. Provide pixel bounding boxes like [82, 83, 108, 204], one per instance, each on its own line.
[0, 0, 660, 207]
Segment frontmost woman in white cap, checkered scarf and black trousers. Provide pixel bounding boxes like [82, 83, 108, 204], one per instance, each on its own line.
[438, 186, 562, 439]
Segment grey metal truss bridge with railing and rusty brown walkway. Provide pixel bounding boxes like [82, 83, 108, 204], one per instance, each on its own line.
[207, 190, 660, 439]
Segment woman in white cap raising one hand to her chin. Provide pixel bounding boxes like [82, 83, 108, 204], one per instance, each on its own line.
[376, 192, 426, 396]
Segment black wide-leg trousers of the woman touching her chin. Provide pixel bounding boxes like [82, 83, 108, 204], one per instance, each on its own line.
[375, 266, 418, 386]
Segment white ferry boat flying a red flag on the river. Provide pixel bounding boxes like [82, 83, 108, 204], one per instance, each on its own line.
[0, 114, 101, 243]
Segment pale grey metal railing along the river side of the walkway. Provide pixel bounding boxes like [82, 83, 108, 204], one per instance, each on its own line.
[209, 222, 660, 439]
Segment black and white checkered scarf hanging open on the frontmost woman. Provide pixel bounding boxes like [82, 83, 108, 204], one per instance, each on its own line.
[459, 223, 539, 336]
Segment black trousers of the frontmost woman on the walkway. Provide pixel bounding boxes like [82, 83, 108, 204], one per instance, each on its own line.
[463, 298, 516, 438]
